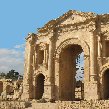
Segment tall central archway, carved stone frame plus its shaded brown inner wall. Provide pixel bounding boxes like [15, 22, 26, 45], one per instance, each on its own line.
[55, 38, 90, 101]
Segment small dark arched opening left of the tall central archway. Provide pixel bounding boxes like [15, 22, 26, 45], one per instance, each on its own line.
[36, 74, 45, 99]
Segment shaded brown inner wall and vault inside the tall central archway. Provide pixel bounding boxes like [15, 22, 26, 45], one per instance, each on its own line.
[59, 44, 83, 101]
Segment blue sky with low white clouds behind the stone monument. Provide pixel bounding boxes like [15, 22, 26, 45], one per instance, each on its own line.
[0, 0, 109, 73]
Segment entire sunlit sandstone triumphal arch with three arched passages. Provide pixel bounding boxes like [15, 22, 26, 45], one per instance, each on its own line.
[22, 10, 109, 101]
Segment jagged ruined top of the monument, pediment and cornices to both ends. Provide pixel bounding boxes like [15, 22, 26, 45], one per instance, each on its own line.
[26, 10, 109, 40]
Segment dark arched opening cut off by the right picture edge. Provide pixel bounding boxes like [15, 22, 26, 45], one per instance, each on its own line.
[103, 69, 109, 99]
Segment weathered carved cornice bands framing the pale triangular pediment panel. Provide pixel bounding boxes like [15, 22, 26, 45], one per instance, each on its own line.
[26, 10, 109, 40]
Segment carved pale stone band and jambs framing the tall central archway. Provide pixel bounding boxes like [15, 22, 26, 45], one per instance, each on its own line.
[55, 38, 90, 100]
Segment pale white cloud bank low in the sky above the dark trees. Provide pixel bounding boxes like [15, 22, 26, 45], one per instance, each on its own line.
[0, 48, 24, 74]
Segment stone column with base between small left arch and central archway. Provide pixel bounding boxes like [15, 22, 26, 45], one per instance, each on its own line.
[44, 37, 54, 99]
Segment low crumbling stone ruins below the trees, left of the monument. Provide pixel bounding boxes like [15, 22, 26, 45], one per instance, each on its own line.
[0, 79, 23, 101]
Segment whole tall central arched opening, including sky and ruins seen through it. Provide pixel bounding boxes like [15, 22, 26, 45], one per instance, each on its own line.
[59, 44, 84, 101]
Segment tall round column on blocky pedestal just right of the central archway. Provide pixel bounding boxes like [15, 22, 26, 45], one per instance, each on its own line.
[84, 33, 99, 100]
